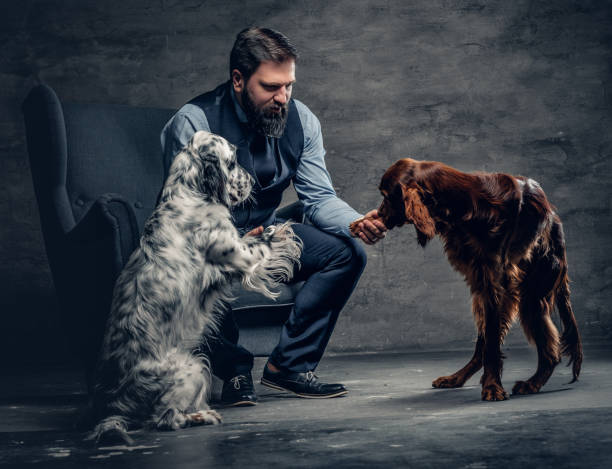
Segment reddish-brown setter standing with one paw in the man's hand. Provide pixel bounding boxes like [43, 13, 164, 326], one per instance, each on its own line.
[351, 158, 582, 401]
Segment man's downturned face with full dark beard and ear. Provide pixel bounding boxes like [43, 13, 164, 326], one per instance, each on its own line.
[232, 60, 295, 137]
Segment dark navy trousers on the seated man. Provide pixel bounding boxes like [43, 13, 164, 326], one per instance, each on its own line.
[204, 223, 366, 380]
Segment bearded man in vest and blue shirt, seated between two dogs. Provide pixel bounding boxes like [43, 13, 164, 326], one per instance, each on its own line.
[161, 28, 386, 405]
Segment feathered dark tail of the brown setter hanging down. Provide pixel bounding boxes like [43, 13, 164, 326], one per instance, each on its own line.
[551, 219, 582, 383]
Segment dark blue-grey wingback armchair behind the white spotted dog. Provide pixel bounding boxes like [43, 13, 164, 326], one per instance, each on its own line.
[23, 85, 303, 376]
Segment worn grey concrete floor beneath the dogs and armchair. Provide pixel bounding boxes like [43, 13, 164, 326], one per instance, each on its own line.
[0, 348, 612, 468]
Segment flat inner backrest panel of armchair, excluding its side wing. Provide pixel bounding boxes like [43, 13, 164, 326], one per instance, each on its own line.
[64, 104, 174, 231]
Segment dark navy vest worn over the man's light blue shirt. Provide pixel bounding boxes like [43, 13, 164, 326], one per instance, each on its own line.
[189, 81, 304, 229]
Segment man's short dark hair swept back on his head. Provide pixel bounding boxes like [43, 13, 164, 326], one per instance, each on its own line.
[230, 27, 298, 81]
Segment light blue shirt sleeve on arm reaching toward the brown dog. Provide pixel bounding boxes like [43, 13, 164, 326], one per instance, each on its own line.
[293, 100, 362, 237]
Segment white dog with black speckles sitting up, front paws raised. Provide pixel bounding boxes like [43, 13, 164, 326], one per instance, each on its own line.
[88, 131, 301, 443]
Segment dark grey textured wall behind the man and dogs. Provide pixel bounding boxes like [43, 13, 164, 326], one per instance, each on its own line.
[0, 0, 612, 359]
